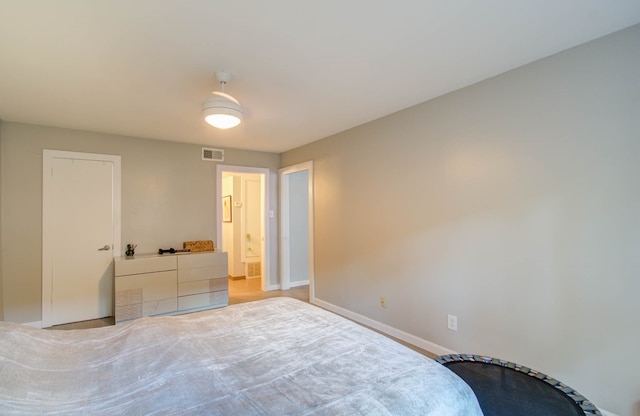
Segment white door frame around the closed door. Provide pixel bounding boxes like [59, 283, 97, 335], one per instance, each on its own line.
[41, 149, 122, 328]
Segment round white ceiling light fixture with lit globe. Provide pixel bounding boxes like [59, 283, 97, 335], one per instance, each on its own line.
[202, 70, 243, 129]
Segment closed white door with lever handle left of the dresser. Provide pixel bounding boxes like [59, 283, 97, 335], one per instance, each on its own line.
[42, 151, 120, 326]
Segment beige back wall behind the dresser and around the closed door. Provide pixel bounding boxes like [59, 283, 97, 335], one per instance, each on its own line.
[1, 122, 279, 322]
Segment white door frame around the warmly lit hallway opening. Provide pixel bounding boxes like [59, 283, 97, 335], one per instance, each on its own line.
[216, 165, 270, 292]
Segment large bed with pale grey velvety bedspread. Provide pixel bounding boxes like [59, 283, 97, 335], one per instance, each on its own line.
[0, 298, 482, 416]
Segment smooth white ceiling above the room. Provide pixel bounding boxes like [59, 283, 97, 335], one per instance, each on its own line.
[0, 0, 640, 152]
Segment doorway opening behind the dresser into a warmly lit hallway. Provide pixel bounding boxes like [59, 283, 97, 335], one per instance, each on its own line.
[216, 165, 273, 291]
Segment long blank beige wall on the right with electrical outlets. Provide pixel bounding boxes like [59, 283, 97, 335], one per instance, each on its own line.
[281, 26, 640, 415]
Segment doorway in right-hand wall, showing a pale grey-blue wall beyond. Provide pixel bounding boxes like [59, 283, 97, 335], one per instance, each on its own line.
[280, 161, 315, 301]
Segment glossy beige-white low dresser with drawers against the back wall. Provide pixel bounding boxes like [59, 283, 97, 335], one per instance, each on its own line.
[115, 252, 229, 323]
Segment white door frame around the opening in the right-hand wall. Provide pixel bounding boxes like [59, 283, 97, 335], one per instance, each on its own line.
[278, 160, 315, 301]
